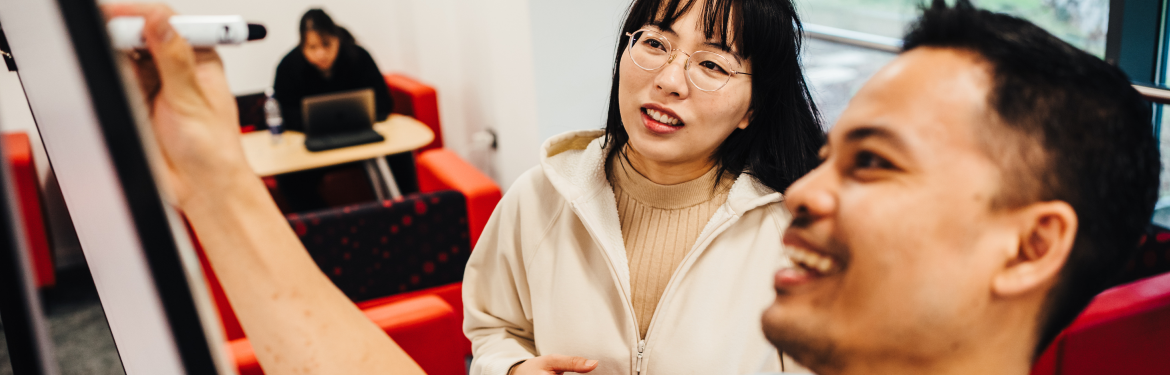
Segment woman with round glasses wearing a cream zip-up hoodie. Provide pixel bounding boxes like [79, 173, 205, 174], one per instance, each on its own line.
[463, 0, 824, 375]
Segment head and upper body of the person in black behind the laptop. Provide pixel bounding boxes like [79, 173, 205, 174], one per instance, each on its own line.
[273, 9, 394, 132]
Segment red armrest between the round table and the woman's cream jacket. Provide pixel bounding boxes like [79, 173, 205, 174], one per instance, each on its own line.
[415, 148, 502, 249]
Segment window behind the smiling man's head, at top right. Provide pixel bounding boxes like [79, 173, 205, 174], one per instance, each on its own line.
[796, 0, 1170, 221]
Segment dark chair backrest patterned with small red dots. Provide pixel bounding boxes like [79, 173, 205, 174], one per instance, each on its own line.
[288, 190, 472, 301]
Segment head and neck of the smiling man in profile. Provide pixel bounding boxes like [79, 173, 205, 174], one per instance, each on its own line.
[763, 0, 1161, 375]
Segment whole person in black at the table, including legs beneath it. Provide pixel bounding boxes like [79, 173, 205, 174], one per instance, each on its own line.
[273, 9, 414, 213]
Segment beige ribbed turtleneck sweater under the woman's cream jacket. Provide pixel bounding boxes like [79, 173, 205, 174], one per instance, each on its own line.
[612, 155, 735, 338]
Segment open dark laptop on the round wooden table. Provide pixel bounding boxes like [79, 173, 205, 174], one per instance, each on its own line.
[301, 89, 386, 151]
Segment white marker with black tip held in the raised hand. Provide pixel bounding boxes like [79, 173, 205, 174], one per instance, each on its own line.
[106, 15, 268, 49]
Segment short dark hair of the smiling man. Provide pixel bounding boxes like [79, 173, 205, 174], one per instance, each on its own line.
[903, 0, 1162, 357]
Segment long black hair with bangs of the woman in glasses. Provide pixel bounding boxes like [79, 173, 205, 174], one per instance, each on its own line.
[605, 0, 825, 192]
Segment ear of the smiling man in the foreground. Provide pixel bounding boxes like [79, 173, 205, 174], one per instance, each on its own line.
[992, 201, 1078, 297]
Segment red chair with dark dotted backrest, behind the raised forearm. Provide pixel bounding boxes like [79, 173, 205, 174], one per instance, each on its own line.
[200, 190, 470, 375]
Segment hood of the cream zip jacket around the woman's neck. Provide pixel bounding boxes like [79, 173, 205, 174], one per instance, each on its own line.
[541, 130, 783, 216]
